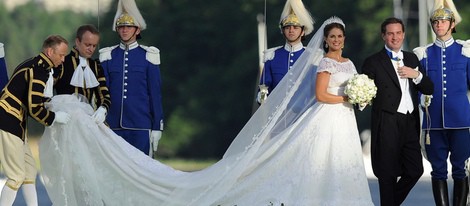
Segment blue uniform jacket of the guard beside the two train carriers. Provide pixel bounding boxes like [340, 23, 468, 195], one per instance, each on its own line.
[100, 42, 163, 130]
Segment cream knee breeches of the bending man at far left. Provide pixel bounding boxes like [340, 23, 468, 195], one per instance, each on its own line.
[0, 130, 37, 191]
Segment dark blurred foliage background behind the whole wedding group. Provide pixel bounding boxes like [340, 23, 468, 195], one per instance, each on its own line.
[0, 0, 470, 159]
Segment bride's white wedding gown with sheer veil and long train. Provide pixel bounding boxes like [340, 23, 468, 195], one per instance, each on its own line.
[40, 17, 373, 206]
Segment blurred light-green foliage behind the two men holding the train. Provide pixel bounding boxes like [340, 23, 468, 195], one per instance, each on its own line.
[0, 1, 94, 136]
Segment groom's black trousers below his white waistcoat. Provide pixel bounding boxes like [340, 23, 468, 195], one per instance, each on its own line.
[373, 112, 424, 206]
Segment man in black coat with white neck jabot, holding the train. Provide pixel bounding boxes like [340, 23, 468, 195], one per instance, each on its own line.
[54, 25, 111, 123]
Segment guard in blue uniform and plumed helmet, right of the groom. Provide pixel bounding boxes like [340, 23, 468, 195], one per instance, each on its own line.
[414, 0, 470, 205]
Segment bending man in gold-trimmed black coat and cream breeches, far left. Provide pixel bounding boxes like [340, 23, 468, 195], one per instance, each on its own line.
[0, 35, 70, 206]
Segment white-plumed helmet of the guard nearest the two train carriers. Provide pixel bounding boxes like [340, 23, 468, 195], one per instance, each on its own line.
[113, 0, 147, 31]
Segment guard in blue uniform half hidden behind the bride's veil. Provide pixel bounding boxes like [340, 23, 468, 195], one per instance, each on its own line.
[256, 0, 313, 104]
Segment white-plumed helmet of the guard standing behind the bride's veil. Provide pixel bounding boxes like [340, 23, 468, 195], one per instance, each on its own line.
[279, 0, 314, 35]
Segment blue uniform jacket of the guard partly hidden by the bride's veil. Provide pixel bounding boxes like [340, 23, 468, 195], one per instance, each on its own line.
[260, 43, 305, 92]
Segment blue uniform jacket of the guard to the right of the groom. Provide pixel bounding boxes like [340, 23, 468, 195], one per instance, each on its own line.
[415, 38, 470, 129]
